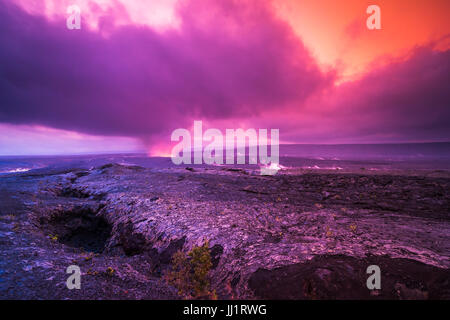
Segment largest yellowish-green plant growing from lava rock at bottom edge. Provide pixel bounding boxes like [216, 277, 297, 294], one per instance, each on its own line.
[167, 241, 216, 299]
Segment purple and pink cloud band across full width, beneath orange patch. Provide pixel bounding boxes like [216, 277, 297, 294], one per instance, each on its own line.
[0, 0, 450, 154]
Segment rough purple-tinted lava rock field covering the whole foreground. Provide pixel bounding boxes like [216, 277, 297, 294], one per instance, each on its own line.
[0, 164, 450, 299]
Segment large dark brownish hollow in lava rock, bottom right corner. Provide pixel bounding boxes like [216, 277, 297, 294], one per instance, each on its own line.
[248, 255, 450, 300]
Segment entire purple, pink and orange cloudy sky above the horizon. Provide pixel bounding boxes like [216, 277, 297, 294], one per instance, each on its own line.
[0, 0, 450, 155]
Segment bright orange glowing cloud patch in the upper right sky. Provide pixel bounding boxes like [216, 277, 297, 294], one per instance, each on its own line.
[277, 0, 450, 76]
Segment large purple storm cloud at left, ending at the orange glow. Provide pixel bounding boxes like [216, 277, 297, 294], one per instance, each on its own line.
[0, 1, 333, 137]
